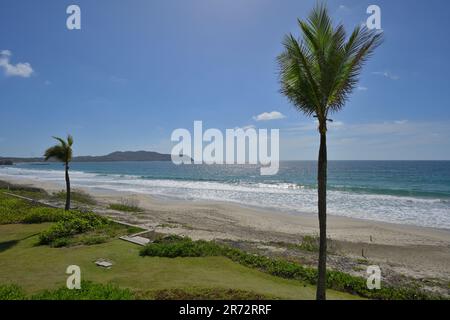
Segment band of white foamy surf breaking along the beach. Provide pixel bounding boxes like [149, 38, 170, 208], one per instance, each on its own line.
[0, 167, 450, 229]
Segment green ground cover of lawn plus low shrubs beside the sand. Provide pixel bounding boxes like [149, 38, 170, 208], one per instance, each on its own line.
[0, 193, 437, 299]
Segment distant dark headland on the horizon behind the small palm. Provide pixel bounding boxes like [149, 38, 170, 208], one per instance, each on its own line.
[0, 151, 178, 163]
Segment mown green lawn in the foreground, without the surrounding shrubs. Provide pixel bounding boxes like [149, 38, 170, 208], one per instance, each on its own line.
[0, 223, 358, 299]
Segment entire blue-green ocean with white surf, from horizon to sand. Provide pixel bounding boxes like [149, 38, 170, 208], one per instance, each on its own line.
[0, 161, 450, 229]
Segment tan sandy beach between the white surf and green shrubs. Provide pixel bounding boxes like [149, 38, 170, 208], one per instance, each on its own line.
[0, 176, 450, 294]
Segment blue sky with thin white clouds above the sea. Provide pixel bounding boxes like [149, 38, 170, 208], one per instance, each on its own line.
[0, 0, 450, 160]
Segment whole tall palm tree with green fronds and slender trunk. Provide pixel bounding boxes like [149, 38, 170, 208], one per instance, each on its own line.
[278, 4, 382, 300]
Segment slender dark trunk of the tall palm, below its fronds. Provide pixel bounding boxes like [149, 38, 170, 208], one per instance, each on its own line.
[316, 129, 327, 300]
